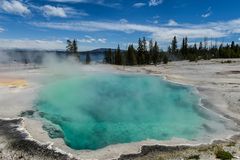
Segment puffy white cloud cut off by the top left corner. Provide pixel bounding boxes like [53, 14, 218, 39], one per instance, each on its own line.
[0, 0, 31, 16]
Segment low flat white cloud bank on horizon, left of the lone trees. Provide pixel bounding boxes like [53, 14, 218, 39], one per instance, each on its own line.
[0, 39, 65, 50]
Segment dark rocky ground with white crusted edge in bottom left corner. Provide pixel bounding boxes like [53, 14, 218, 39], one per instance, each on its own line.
[0, 118, 77, 160]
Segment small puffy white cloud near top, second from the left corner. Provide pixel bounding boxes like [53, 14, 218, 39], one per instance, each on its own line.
[41, 5, 67, 18]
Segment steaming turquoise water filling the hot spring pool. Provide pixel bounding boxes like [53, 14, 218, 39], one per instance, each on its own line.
[37, 74, 217, 150]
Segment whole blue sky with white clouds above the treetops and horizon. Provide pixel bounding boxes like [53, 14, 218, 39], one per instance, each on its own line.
[0, 0, 240, 51]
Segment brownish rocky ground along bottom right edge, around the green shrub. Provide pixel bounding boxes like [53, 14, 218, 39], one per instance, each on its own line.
[119, 135, 240, 160]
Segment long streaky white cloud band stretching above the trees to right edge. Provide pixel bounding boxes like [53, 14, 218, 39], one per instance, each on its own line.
[31, 18, 240, 42]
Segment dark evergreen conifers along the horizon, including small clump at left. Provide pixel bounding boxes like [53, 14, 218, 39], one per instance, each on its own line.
[66, 36, 240, 66]
